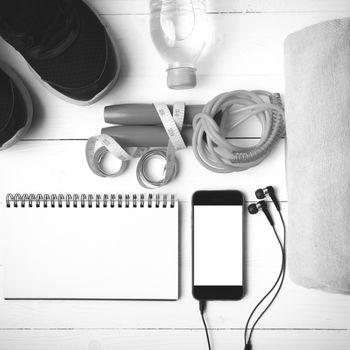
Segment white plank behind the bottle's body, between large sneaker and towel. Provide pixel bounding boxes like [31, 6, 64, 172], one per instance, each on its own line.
[103, 12, 349, 77]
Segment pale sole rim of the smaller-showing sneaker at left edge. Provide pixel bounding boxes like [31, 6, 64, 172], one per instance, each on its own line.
[0, 61, 34, 151]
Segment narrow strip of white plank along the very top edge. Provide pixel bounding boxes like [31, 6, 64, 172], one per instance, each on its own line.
[90, 0, 350, 14]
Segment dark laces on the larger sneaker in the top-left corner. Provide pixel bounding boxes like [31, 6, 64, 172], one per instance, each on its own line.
[0, 0, 75, 54]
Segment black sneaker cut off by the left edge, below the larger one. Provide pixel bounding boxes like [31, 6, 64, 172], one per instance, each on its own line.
[0, 62, 33, 151]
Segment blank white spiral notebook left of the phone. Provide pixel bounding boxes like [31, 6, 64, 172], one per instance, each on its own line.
[1, 194, 179, 300]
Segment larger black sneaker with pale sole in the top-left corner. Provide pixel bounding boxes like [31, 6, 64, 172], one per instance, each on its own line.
[0, 0, 119, 105]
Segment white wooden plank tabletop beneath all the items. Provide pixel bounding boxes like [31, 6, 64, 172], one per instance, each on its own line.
[0, 0, 350, 350]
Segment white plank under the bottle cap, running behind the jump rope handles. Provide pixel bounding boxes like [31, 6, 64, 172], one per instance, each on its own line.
[13, 76, 284, 140]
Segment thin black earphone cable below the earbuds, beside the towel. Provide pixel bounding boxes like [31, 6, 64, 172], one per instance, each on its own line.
[244, 211, 286, 348]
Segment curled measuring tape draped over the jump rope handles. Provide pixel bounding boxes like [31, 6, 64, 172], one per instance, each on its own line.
[85, 103, 186, 188]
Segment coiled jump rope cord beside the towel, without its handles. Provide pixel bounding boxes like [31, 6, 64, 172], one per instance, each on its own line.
[192, 90, 285, 173]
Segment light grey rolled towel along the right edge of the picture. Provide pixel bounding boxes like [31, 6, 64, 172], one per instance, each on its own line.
[285, 18, 350, 293]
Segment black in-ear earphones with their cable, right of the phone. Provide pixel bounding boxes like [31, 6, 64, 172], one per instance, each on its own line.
[244, 186, 286, 350]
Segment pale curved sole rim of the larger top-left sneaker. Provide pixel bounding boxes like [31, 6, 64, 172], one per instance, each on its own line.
[26, 0, 120, 106]
